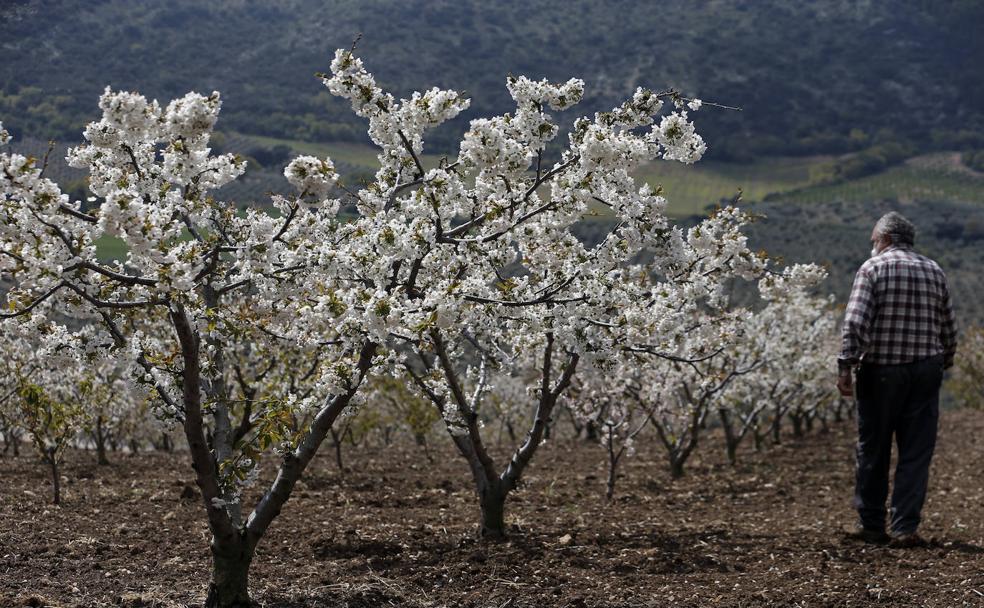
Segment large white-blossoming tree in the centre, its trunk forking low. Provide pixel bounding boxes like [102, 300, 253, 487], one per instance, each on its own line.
[308, 51, 784, 537]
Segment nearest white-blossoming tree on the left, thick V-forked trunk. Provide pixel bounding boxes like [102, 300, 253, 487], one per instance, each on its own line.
[0, 90, 384, 607]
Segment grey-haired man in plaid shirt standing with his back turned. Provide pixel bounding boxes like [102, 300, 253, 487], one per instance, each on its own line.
[837, 212, 957, 547]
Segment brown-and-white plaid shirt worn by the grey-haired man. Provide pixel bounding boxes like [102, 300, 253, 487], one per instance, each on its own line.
[837, 245, 957, 368]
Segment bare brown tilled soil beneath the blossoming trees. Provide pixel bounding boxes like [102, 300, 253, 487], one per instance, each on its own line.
[0, 411, 984, 608]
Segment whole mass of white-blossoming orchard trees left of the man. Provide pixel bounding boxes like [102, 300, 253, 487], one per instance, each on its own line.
[0, 50, 856, 607]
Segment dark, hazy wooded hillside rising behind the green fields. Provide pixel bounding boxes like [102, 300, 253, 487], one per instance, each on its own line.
[0, 0, 984, 159]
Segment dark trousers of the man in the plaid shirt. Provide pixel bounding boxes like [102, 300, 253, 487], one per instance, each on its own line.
[854, 356, 943, 534]
